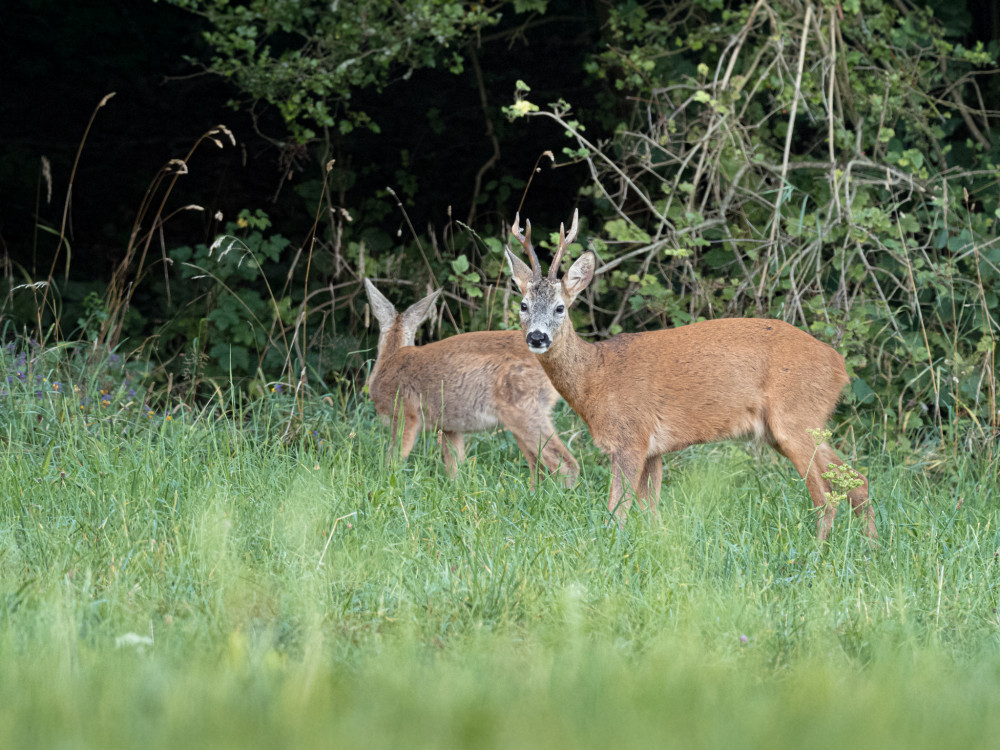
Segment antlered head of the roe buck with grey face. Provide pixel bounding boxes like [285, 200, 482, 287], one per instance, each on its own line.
[506, 211, 597, 354]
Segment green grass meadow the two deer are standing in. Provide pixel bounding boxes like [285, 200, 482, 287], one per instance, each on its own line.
[0, 353, 1000, 748]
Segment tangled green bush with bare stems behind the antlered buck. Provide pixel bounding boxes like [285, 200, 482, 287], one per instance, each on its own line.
[508, 2, 1000, 446]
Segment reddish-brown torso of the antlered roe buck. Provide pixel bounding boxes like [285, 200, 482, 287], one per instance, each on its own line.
[538, 318, 848, 455]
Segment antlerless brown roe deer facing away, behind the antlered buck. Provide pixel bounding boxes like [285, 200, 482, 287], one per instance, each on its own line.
[365, 279, 579, 487]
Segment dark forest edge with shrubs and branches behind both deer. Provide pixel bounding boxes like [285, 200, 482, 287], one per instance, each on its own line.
[0, 0, 1000, 441]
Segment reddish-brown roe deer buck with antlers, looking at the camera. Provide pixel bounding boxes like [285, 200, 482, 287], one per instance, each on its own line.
[506, 212, 877, 540]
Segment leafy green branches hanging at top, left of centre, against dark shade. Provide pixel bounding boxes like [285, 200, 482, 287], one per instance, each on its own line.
[170, 0, 512, 141]
